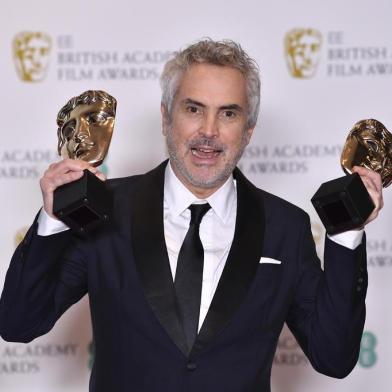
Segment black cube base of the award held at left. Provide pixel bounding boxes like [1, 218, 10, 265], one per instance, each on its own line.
[53, 170, 113, 234]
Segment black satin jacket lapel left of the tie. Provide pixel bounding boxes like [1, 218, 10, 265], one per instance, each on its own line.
[131, 162, 187, 355]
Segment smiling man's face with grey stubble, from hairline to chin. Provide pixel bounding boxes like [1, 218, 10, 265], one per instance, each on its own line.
[162, 64, 253, 197]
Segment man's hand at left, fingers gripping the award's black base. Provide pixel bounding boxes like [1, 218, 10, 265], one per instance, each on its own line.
[40, 159, 106, 219]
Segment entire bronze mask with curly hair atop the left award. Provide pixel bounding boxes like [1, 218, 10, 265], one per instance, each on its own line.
[57, 90, 116, 166]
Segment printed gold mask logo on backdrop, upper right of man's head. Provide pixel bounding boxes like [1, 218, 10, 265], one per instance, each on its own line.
[284, 28, 322, 79]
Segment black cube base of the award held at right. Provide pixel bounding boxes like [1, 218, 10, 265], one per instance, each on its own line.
[312, 173, 375, 234]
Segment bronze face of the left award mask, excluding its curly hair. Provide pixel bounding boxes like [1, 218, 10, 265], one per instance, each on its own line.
[58, 101, 114, 166]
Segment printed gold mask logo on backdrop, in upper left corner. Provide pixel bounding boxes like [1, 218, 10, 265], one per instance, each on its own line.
[12, 31, 52, 82]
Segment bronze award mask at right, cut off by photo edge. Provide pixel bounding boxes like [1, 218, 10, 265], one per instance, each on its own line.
[340, 119, 392, 188]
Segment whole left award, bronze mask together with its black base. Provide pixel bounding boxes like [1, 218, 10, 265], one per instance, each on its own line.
[53, 90, 117, 233]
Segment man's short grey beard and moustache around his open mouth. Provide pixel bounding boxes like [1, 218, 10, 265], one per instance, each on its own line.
[166, 129, 248, 189]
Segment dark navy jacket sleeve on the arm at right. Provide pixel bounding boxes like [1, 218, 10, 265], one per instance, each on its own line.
[287, 218, 367, 378]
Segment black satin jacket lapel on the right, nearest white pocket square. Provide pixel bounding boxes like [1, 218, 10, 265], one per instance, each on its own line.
[190, 169, 265, 356]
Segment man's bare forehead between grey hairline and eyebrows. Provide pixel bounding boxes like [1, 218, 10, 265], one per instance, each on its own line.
[176, 64, 246, 105]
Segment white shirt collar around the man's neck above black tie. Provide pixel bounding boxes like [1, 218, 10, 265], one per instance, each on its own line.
[164, 161, 237, 223]
